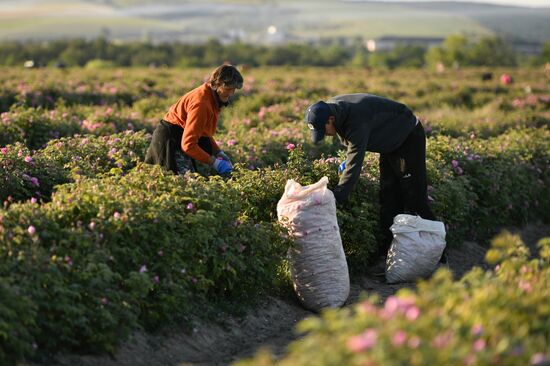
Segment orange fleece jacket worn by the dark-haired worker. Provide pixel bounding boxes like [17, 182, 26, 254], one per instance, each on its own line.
[164, 83, 220, 164]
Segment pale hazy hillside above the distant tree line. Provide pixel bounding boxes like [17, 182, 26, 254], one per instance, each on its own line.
[0, 0, 550, 43]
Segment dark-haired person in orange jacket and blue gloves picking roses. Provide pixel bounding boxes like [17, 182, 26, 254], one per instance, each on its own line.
[145, 65, 243, 175]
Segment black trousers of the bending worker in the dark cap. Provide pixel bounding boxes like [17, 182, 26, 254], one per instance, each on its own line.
[380, 122, 435, 255]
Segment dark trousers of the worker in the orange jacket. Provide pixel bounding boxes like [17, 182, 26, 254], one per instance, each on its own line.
[145, 120, 212, 174]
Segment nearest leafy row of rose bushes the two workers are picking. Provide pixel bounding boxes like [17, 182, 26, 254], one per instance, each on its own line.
[0, 124, 550, 361]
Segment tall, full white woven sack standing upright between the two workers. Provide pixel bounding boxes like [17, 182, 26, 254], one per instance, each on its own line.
[277, 177, 350, 311]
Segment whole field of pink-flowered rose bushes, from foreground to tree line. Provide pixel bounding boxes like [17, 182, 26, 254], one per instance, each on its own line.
[0, 64, 550, 364]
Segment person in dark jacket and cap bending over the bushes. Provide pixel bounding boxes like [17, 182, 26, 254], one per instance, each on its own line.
[305, 94, 435, 256]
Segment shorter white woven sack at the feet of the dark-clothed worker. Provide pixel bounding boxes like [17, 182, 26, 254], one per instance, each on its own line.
[386, 214, 446, 283]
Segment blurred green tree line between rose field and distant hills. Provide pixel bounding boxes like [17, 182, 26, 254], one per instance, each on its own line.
[0, 35, 550, 69]
